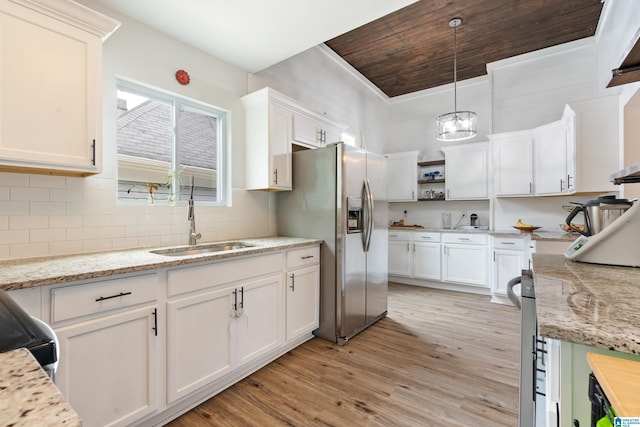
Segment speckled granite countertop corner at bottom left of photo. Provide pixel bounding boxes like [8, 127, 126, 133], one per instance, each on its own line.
[0, 348, 82, 427]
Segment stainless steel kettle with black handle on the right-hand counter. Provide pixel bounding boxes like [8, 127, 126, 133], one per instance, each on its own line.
[566, 196, 632, 236]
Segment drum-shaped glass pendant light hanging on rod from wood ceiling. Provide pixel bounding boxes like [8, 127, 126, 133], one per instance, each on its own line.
[437, 18, 478, 141]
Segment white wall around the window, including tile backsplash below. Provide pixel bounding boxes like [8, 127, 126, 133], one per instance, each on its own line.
[0, 0, 276, 259]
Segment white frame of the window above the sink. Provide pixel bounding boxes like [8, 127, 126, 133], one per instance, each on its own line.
[116, 79, 231, 206]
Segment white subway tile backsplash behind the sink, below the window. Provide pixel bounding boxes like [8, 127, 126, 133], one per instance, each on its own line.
[0, 173, 275, 260]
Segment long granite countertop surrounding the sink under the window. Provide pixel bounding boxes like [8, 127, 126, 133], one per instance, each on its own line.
[0, 237, 322, 291]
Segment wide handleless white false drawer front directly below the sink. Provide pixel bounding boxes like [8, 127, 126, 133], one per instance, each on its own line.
[167, 252, 283, 296]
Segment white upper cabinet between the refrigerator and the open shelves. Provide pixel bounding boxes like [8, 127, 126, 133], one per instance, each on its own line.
[384, 151, 423, 202]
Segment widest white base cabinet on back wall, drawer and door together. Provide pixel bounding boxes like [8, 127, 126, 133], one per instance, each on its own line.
[442, 233, 489, 287]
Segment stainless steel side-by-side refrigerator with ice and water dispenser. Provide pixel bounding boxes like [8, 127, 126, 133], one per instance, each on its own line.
[277, 143, 388, 344]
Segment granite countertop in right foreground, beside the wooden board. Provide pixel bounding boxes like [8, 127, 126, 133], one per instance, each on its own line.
[533, 254, 640, 355]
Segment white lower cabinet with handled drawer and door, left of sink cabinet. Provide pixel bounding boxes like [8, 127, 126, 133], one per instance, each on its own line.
[51, 274, 159, 426]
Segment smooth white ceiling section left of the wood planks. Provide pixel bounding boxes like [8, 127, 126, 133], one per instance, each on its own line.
[92, 0, 416, 73]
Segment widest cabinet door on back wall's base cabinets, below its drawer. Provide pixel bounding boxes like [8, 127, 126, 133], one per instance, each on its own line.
[442, 245, 489, 287]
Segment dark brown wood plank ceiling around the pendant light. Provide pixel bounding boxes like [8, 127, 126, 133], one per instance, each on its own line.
[325, 0, 602, 98]
